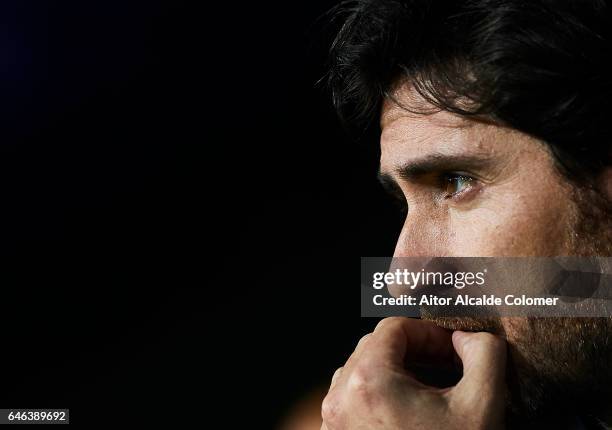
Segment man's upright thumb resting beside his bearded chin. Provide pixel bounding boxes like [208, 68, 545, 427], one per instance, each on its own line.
[453, 331, 506, 398]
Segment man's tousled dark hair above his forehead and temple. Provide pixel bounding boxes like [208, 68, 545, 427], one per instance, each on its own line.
[327, 0, 612, 179]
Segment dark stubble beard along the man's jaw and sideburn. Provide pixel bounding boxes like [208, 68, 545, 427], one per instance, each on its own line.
[424, 187, 612, 420]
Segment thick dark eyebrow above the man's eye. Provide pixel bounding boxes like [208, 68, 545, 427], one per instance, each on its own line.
[378, 154, 491, 187]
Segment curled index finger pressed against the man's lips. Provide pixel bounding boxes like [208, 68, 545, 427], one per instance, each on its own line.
[360, 317, 454, 370]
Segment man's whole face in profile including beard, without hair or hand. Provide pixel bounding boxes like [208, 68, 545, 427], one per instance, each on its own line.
[380, 86, 612, 412]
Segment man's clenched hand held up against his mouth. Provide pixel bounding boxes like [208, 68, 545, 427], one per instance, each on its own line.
[321, 318, 506, 430]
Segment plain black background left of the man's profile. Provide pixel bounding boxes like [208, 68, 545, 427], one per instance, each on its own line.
[0, 0, 400, 428]
